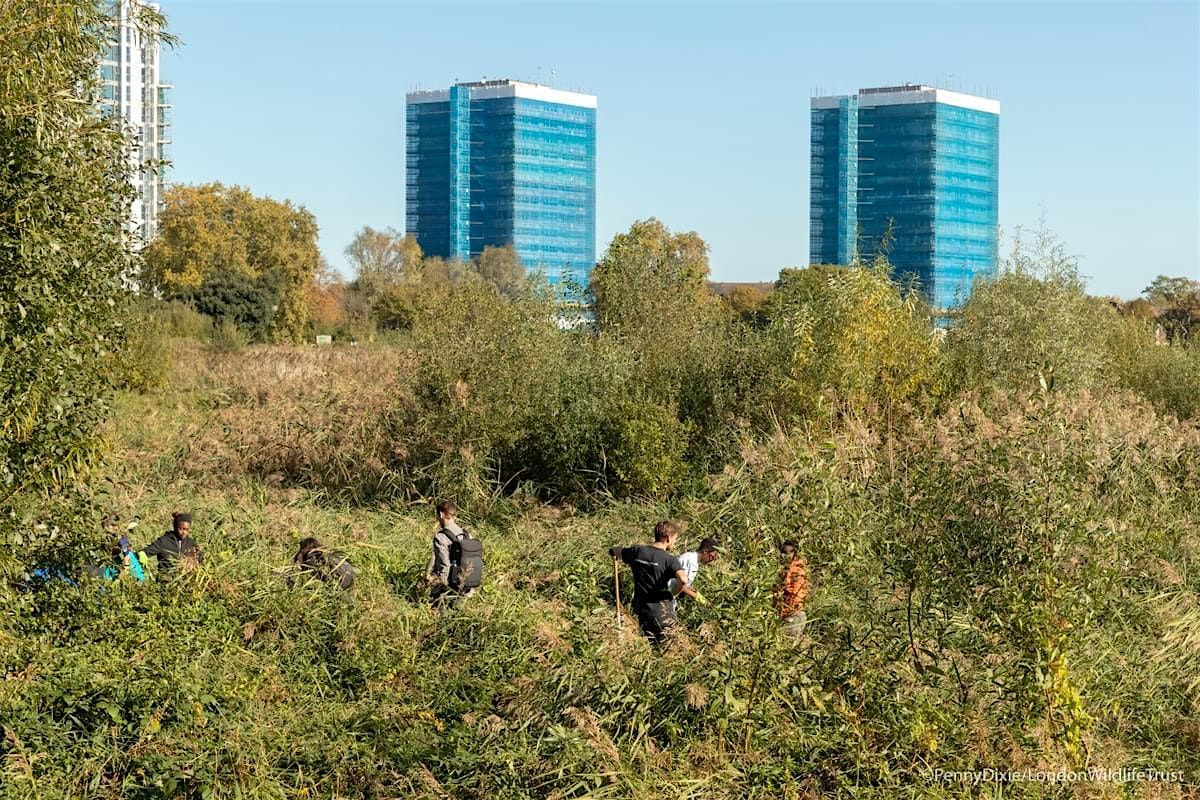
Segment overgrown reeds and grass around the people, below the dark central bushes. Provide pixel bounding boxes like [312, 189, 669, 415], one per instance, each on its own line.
[0, 343, 1200, 799]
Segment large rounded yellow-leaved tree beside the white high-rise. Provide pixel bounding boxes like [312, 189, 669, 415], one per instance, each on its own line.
[144, 184, 320, 342]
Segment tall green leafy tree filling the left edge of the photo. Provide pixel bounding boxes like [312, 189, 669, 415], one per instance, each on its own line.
[0, 0, 170, 575]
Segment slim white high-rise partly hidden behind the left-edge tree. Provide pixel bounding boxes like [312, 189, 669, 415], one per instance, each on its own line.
[100, 0, 172, 246]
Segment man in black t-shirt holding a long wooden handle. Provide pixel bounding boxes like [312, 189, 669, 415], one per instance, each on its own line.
[608, 521, 696, 644]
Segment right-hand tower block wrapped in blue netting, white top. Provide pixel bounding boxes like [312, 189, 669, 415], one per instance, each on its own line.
[809, 84, 1000, 308]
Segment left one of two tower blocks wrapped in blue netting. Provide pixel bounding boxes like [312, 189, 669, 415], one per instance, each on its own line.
[406, 80, 596, 287]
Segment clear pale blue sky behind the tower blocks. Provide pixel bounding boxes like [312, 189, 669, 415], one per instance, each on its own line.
[162, 0, 1200, 297]
